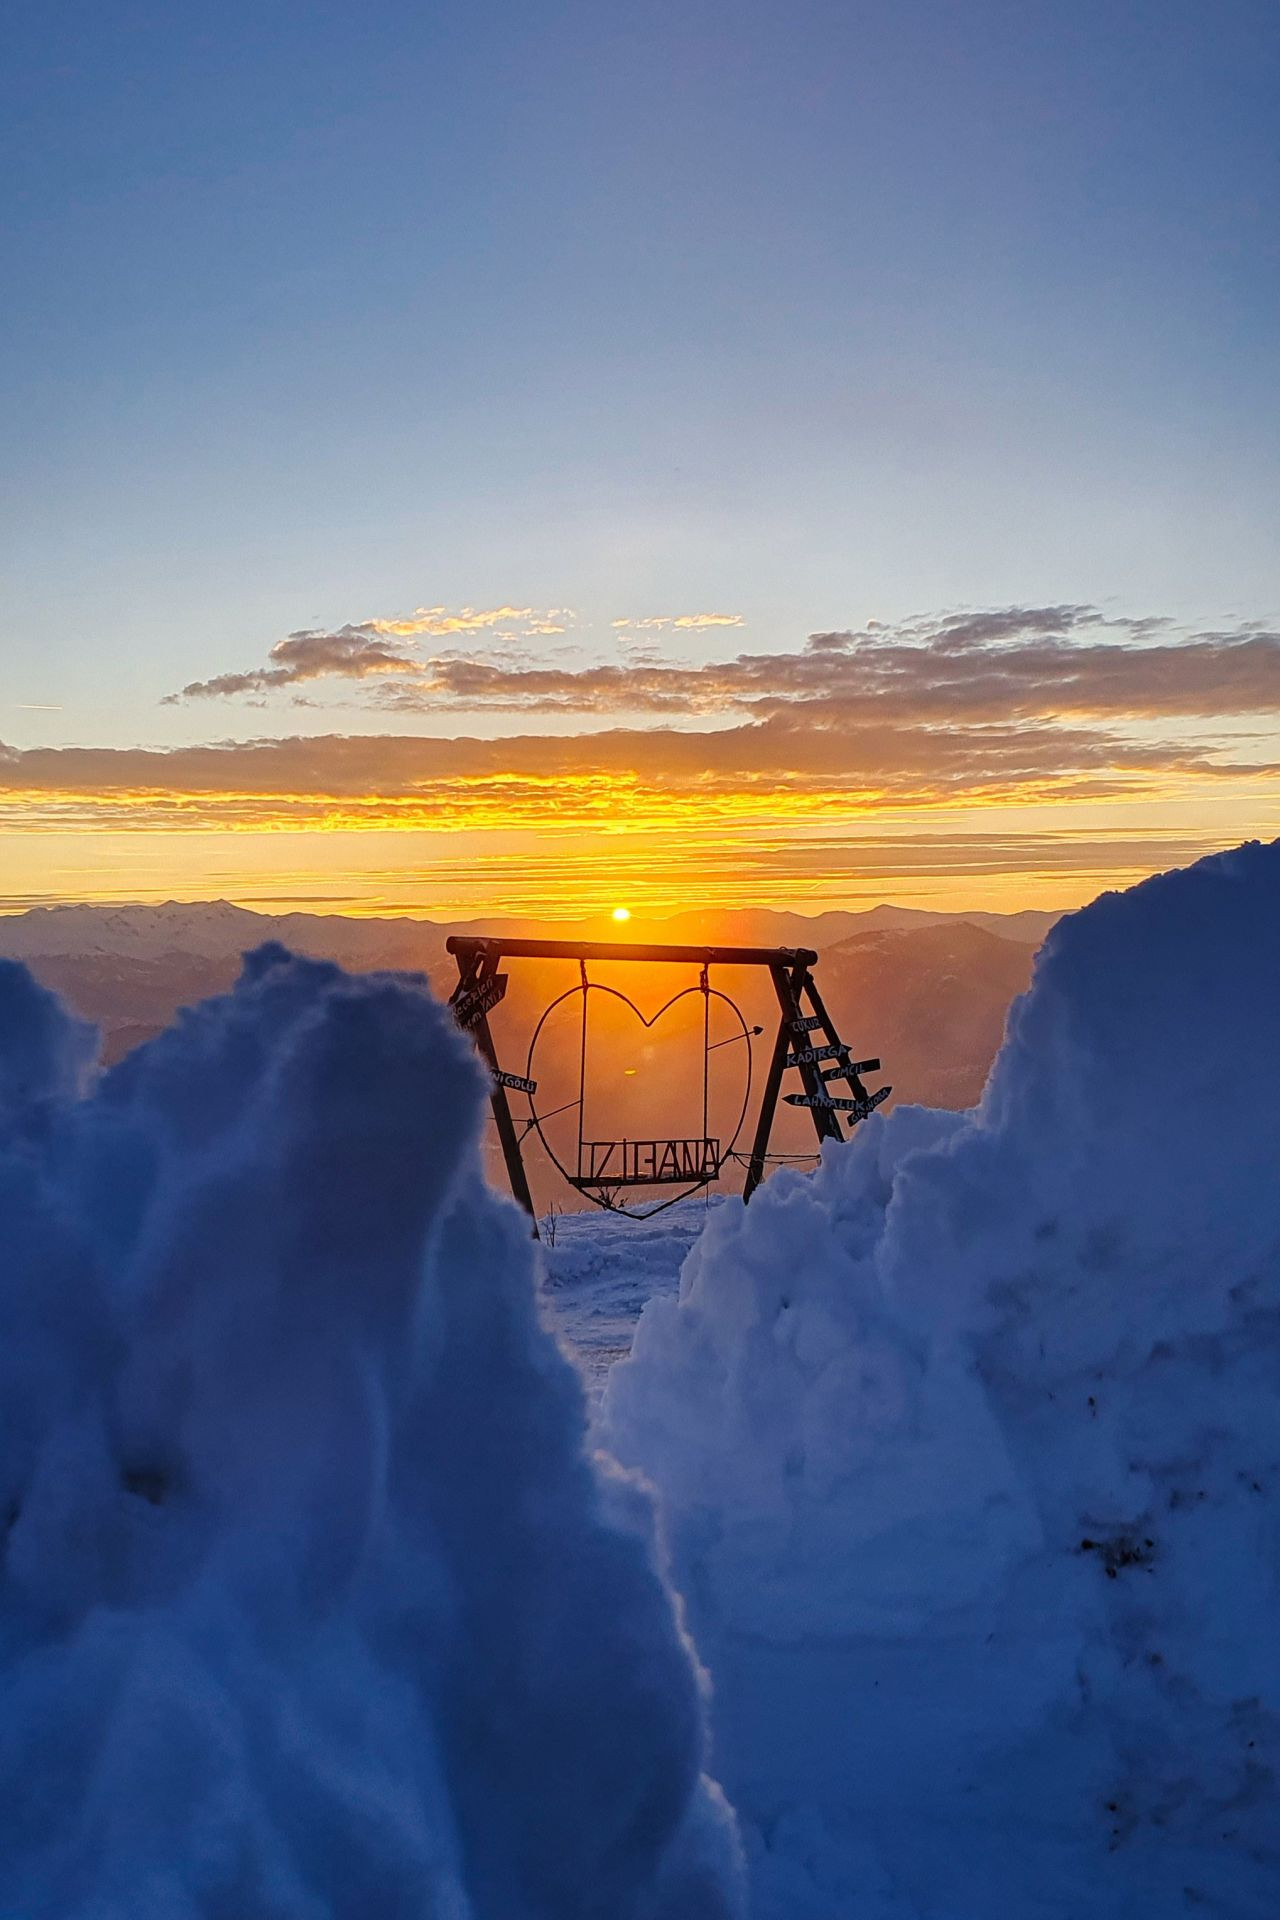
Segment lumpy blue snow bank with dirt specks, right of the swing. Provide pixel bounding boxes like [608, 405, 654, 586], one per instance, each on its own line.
[604, 845, 1280, 1920]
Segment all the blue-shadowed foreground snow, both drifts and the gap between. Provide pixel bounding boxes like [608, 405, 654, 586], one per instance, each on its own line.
[0, 845, 1280, 1920]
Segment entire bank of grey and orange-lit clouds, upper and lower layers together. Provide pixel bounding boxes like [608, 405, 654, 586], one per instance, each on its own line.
[0, 603, 1280, 829]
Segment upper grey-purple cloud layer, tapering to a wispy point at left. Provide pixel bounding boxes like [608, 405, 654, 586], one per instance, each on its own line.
[175, 603, 1280, 730]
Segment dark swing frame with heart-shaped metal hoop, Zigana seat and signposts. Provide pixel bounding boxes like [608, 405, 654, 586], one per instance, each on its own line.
[445, 933, 892, 1231]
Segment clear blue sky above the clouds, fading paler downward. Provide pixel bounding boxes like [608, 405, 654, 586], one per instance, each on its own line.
[0, 0, 1280, 913]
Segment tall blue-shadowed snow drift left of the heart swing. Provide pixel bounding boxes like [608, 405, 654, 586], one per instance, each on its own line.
[0, 948, 739, 1920]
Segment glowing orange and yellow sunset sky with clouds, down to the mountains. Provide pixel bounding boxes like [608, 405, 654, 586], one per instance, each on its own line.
[0, 607, 1280, 918]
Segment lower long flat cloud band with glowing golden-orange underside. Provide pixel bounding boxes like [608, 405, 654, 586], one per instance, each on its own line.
[0, 707, 1270, 826]
